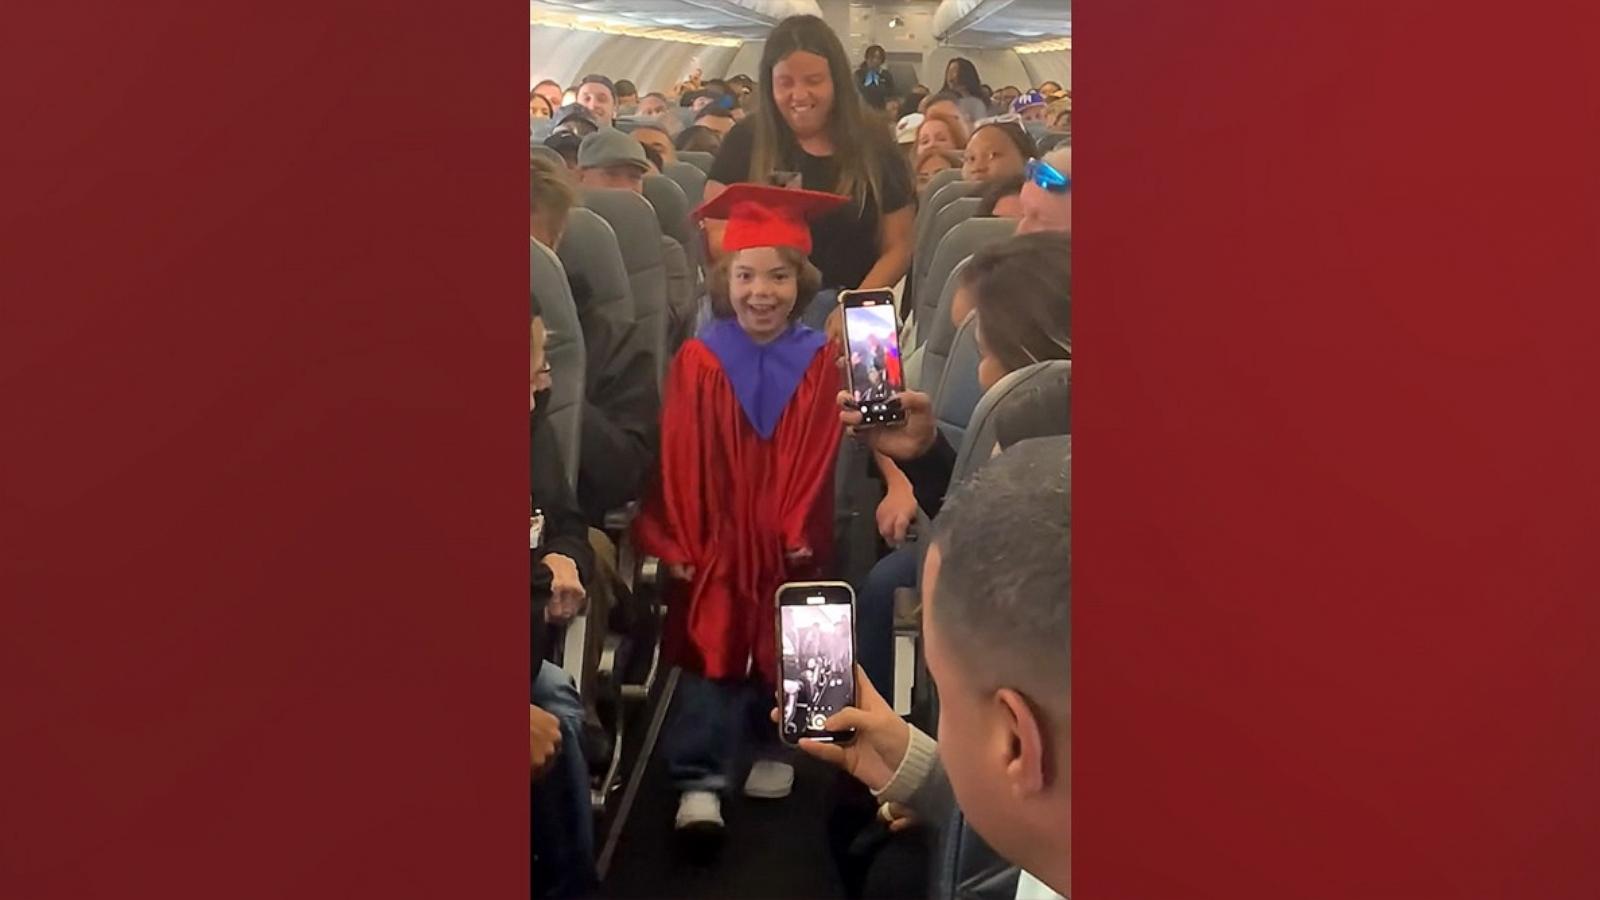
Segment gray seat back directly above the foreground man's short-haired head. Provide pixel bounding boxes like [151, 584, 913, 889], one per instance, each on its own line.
[950, 357, 1072, 484]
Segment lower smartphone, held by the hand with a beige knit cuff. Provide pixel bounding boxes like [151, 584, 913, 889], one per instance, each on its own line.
[778, 581, 856, 745]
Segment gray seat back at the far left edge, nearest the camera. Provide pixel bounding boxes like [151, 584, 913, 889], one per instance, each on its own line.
[528, 240, 586, 490]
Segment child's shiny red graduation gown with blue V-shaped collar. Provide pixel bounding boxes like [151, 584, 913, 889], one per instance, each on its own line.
[635, 320, 842, 684]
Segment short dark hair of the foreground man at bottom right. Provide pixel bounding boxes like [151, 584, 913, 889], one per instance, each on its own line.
[930, 437, 1072, 703]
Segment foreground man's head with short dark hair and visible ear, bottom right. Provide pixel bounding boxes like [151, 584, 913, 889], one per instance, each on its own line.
[922, 437, 1072, 895]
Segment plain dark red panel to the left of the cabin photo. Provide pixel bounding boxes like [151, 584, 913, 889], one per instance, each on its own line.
[0, 0, 528, 900]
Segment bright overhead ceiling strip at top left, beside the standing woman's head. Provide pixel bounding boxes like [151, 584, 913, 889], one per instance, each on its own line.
[528, 0, 822, 40]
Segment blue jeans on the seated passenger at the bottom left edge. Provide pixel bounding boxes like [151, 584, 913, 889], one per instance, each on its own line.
[531, 660, 595, 898]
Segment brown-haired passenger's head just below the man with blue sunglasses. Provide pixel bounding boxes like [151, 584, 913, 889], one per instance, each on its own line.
[950, 232, 1072, 384]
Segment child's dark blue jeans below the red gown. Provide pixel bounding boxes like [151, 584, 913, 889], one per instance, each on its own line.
[661, 671, 781, 793]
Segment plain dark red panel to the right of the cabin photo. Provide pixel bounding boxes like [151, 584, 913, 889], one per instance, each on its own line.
[1074, 0, 1600, 900]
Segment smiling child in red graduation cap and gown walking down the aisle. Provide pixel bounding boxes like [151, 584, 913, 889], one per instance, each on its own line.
[637, 184, 845, 831]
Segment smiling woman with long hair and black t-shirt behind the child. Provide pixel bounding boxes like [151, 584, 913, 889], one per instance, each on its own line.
[706, 16, 915, 288]
